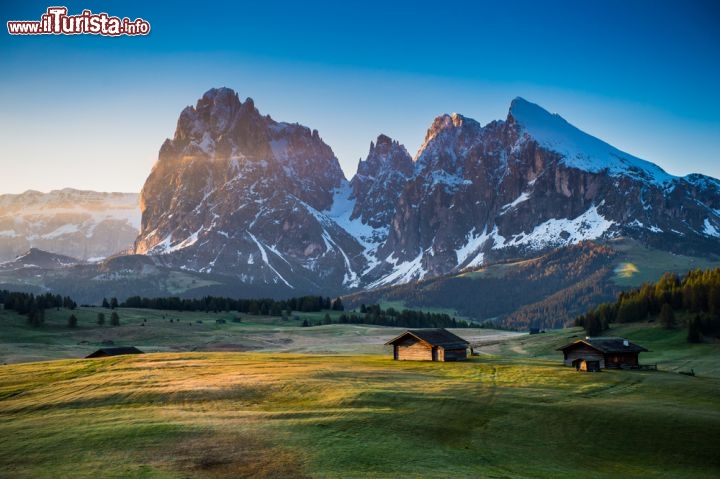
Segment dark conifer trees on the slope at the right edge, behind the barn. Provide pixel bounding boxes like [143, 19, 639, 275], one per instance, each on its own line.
[575, 268, 720, 342]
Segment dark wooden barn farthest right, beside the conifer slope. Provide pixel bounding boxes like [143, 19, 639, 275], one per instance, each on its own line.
[557, 337, 647, 371]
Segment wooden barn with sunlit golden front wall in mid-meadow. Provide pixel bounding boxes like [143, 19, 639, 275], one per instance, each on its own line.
[385, 329, 470, 361]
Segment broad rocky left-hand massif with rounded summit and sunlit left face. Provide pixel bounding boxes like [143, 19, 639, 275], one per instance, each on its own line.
[135, 88, 365, 293]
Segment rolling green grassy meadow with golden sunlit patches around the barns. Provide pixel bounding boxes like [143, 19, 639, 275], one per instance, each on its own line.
[0, 308, 720, 478]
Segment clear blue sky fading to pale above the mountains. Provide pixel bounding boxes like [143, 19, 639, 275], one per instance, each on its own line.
[0, 0, 720, 194]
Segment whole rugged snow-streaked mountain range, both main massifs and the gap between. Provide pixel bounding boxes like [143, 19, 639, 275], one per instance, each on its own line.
[0, 88, 720, 328]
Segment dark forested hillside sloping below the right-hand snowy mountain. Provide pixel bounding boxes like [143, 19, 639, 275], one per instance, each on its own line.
[343, 241, 621, 330]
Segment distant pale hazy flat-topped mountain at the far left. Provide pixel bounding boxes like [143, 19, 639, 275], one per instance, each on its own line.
[0, 188, 140, 262]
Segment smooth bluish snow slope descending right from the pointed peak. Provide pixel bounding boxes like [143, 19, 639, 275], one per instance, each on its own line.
[510, 97, 676, 186]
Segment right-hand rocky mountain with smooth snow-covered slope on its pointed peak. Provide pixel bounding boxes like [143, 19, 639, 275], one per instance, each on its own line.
[373, 98, 720, 285]
